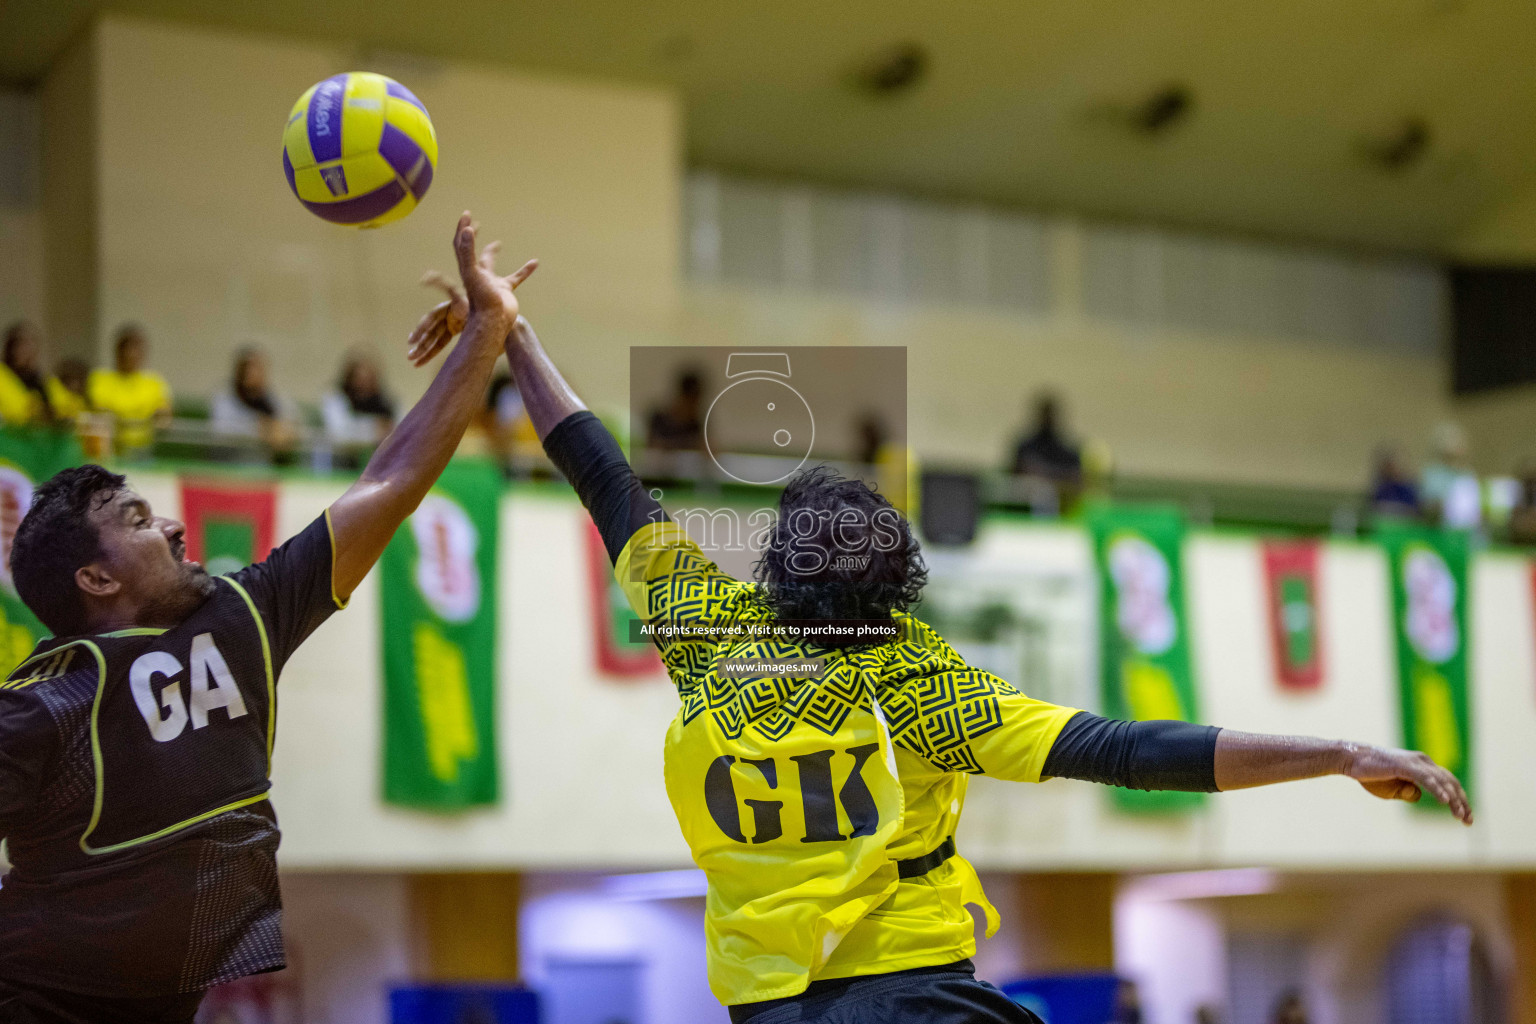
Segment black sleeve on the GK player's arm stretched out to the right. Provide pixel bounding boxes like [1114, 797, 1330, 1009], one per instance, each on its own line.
[1040, 711, 1221, 792]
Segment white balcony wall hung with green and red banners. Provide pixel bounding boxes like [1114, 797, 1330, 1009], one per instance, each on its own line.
[122, 474, 1536, 870]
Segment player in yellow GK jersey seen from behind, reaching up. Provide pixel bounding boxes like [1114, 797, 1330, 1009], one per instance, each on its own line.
[410, 282, 1471, 1024]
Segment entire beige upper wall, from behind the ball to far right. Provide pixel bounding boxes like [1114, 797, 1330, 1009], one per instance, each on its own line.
[32, 17, 1462, 487]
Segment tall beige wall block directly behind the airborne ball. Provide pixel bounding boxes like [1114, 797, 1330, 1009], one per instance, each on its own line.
[87, 18, 680, 402]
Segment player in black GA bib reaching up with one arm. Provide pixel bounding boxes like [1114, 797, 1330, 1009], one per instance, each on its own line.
[0, 215, 535, 1024]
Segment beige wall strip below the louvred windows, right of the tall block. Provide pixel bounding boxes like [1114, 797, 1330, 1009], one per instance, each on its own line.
[684, 287, 1447, 488]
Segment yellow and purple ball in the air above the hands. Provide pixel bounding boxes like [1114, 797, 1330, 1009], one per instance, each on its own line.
[283, 71, 438, 227]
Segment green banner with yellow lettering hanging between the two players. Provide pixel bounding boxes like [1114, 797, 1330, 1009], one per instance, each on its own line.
[379, 462, 502, 811]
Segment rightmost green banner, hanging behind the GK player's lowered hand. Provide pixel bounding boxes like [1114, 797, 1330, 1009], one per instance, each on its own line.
[1376, 522, 1471, 808]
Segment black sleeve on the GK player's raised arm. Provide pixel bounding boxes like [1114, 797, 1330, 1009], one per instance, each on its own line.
[544, 410, 667, 562]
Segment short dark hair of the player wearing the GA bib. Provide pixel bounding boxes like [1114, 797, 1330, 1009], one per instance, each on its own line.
[11, 465, 124, 637]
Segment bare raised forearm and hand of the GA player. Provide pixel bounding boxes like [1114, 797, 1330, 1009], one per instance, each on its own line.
[330, 213, 538, 600]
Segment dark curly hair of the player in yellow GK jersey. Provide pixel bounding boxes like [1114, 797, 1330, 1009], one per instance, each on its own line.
[753, 465, 928, 646]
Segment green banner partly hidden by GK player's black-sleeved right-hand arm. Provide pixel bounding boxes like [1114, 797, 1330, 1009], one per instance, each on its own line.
[1084, 505, 1204, 812]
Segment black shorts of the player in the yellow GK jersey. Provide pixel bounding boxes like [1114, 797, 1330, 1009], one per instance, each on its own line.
[730, 960, 1041, 1024]
